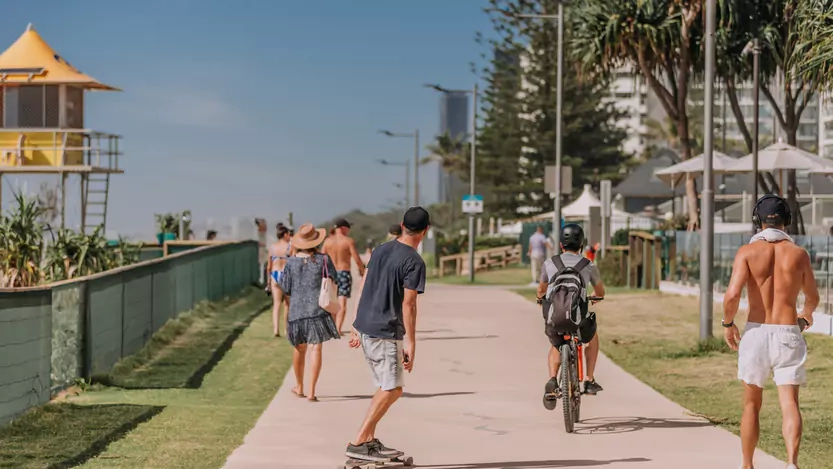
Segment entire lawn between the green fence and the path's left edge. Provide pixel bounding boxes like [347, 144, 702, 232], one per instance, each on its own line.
[0, 288, 292, 469]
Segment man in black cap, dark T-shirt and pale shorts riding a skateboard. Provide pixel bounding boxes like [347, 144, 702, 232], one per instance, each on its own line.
[346, 207, 430, 462]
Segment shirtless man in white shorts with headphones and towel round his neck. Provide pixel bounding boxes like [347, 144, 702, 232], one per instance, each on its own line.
[723, 195, 819, 469]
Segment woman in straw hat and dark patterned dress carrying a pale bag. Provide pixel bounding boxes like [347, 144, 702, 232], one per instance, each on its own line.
[280, 223, 341, 401]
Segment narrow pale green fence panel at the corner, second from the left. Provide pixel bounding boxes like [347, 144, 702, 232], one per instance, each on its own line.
[52, 282, 86, 388]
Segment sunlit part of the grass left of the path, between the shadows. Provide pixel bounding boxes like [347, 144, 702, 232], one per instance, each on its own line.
[70, 289, 292, 469]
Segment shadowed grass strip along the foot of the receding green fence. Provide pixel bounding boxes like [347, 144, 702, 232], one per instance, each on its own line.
[102, 288, 269, 389]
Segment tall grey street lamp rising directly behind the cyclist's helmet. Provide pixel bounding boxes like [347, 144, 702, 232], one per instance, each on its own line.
[498, 1, 564, 252]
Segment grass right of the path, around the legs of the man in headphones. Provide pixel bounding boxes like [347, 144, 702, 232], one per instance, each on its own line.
[525, 293, 833, 469]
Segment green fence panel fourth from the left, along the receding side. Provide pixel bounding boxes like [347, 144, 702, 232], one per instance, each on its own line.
[121, 267, 154, 357]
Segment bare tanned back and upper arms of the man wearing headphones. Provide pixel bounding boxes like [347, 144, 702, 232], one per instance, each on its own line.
[727, 241, 818, 325]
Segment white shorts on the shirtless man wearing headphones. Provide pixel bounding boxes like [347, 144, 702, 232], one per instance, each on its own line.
[738, 322, 807, 388]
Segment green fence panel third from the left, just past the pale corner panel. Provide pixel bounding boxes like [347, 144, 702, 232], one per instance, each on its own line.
[87, 274, 124, 376]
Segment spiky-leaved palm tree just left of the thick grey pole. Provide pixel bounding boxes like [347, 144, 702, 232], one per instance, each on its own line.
[570, 0, 702, 229]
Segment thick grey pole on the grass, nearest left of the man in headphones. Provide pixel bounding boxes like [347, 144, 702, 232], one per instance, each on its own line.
[700, 0, 717, 340]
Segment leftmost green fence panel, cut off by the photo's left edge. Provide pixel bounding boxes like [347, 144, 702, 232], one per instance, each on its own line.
[0, 289, 52, 423]
